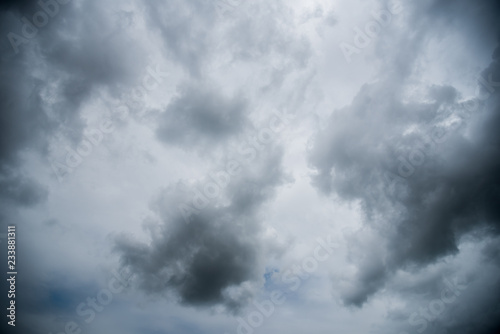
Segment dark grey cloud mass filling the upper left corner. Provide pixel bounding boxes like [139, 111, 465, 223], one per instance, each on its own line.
[0, 1, 146, 180]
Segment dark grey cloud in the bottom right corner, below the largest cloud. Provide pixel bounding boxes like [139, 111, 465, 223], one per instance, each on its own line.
[374, 231, 500, 334]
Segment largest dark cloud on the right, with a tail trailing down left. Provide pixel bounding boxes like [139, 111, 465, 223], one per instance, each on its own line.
[310, 42, 500, 306]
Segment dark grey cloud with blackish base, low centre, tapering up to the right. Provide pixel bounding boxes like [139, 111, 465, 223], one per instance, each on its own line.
[116, 148, 284, 312]
